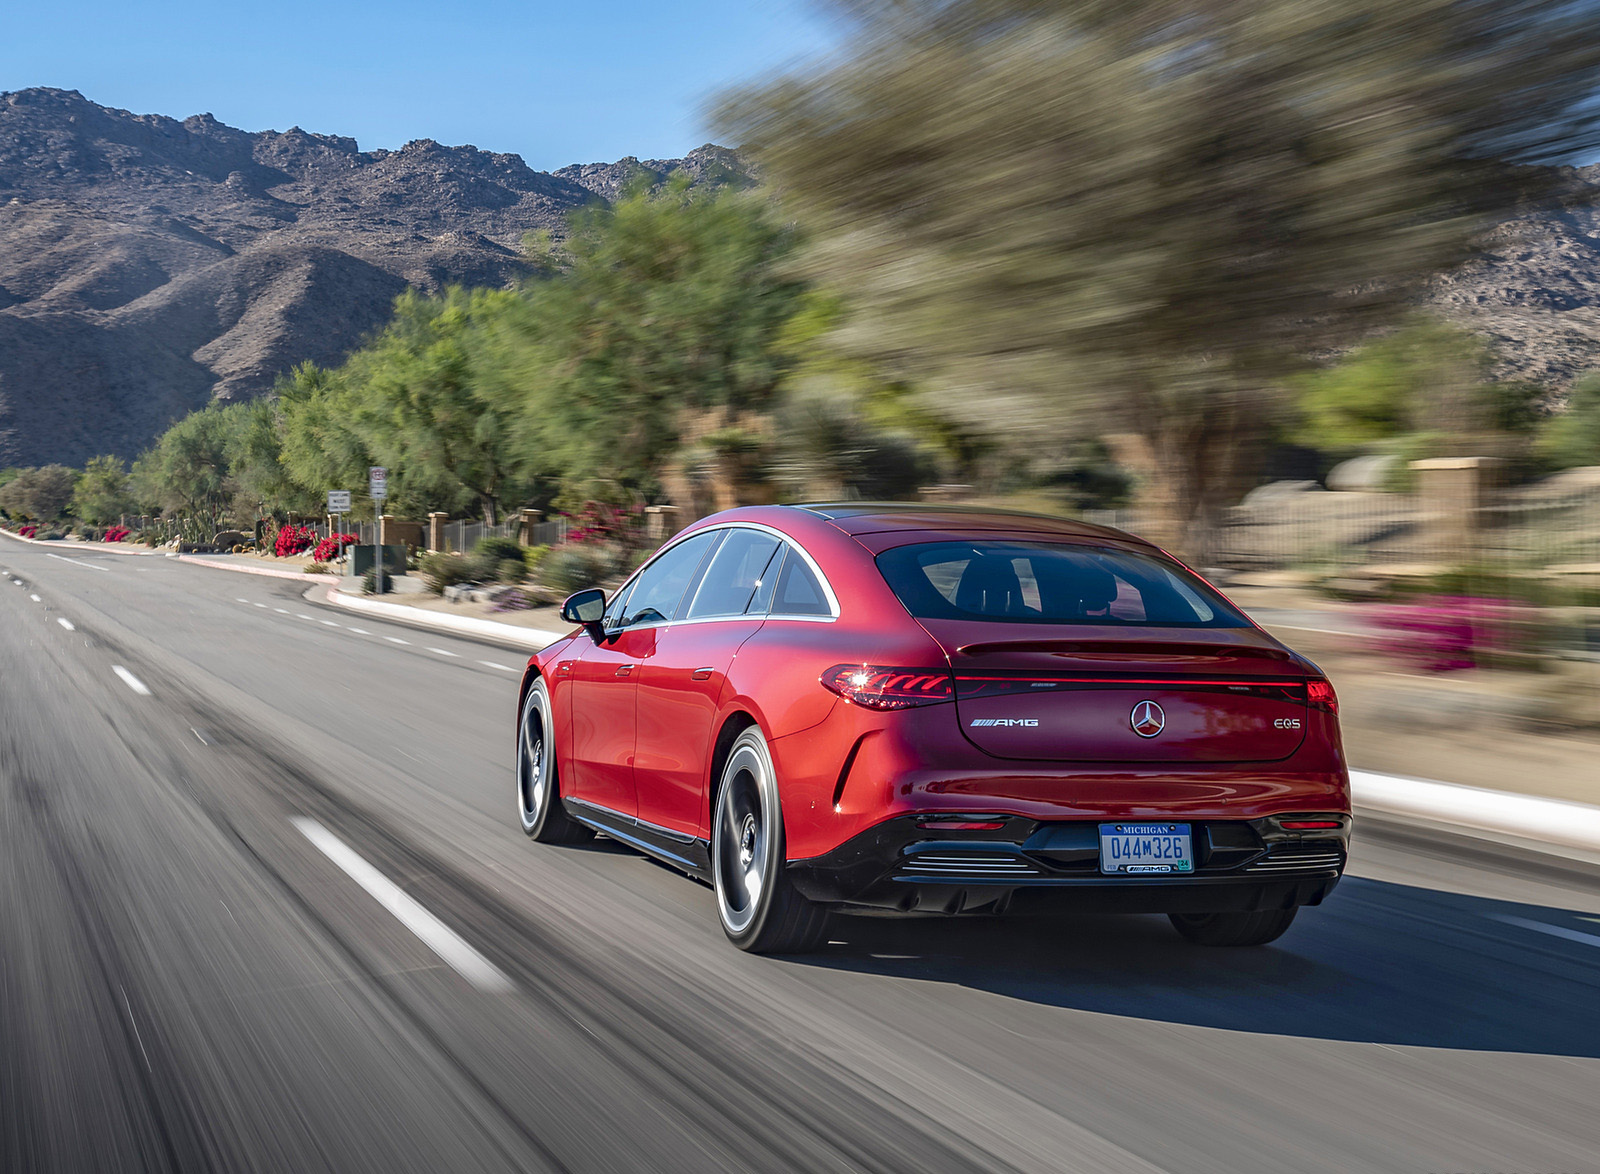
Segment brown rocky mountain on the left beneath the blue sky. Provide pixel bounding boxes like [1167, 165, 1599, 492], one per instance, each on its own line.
[0, 90, 746, 464]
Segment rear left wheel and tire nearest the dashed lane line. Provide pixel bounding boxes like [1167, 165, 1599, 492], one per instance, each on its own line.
[710, 726, 827, 953]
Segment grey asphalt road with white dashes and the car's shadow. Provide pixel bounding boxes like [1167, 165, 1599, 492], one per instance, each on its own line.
[0, 539, 1600, 1174]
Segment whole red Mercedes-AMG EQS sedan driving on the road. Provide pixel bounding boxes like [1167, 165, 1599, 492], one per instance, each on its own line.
[517, 502, 1350, 952]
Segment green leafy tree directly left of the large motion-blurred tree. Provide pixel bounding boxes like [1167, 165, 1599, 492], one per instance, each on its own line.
[475, 178, 803, 493]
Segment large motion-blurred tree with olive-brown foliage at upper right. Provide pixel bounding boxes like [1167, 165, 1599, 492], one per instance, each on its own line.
[720, 0, 1600, 557]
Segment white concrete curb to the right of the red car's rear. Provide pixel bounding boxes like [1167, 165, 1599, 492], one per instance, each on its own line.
[1350, 771, 1600, 853]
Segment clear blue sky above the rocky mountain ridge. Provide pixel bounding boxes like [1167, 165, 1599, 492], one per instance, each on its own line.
[0, 0, 829, 170]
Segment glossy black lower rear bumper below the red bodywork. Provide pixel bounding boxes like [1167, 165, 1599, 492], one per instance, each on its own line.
[789, 813, 1350, 913]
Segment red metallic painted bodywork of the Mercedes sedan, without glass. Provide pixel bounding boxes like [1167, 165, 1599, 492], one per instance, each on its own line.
[523, 507, 1350, 861]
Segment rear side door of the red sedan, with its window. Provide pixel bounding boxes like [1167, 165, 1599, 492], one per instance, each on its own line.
[634, 526, 782, 835]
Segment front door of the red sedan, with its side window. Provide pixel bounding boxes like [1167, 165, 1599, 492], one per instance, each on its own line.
[566, 533, 720, 816]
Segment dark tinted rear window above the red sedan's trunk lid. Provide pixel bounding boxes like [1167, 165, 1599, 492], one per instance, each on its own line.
[878, 541, 1250, 627]
